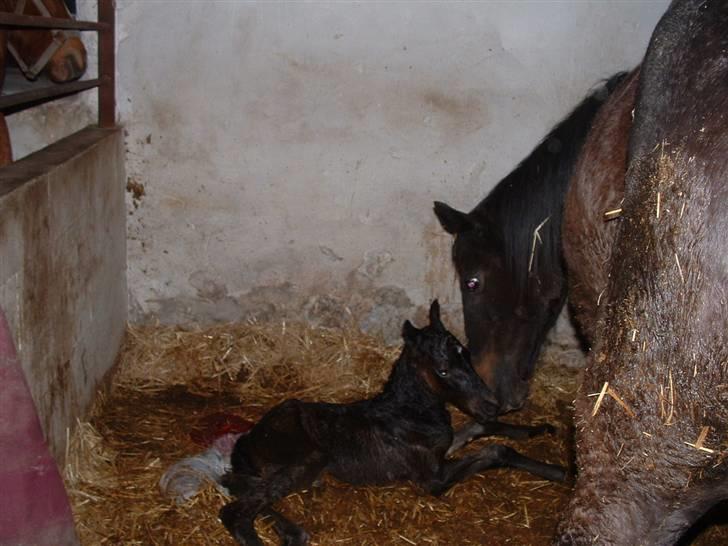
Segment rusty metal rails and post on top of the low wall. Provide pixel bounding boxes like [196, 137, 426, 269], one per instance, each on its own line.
[0, 0, 116, 128]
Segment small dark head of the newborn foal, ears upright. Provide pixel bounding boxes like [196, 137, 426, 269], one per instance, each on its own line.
[402, 300, 498, 422]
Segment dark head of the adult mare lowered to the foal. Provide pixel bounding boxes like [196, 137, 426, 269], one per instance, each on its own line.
[435, 202, 565, 412]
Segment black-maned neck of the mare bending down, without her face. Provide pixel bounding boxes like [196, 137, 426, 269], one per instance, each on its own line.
[471, 72, 627, 290]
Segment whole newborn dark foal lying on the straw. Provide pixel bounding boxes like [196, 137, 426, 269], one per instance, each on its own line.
[220, 301, 565, 546]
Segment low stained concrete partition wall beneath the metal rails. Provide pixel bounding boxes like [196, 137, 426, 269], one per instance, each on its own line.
[0, 128, 127, 463]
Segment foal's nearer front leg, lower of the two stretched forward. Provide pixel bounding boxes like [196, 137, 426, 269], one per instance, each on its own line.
[423, 444, 566, 496]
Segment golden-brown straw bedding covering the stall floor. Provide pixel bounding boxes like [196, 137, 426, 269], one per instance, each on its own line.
[65, 323, 728, 546]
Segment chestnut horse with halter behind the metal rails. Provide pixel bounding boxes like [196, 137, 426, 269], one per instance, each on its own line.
[0, 0, 86, 166]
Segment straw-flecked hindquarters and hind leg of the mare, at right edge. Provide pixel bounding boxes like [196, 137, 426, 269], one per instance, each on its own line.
[557, 0, 728, 545]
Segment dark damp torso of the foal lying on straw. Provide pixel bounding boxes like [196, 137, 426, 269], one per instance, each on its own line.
[232, 366, 452, 485]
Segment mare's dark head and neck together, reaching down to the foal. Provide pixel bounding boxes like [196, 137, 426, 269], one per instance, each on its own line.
[435, 73, 624, 412]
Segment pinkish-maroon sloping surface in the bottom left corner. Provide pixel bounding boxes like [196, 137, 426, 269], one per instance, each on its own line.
[0, 309, 78, 546]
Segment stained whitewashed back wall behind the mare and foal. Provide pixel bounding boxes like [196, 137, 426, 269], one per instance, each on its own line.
[118, 0, 667, 337]
